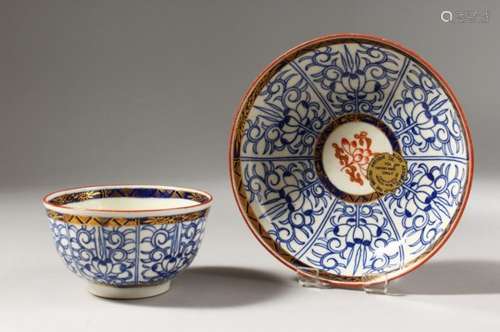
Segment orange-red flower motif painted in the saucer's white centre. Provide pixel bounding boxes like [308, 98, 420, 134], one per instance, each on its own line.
[332, 131, 374, 185]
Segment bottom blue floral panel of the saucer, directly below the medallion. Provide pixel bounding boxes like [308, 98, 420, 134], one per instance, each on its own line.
[308, 202, 404, 275]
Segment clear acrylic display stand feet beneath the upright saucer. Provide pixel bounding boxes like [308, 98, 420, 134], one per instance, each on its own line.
[297, 267, 396, 295]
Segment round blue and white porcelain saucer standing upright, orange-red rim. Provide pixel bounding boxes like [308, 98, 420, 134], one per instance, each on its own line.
[229, 34, 473, 287]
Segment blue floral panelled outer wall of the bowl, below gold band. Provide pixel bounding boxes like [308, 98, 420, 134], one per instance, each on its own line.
[49, 217, 205, 286]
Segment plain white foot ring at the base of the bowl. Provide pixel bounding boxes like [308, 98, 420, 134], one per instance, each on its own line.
[87, 280, 171, 299]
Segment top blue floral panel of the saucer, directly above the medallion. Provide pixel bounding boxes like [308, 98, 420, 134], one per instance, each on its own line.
[292, 44, 406, 116]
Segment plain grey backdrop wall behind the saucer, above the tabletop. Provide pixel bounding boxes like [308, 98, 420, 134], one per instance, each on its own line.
[0, 0, 500, 187]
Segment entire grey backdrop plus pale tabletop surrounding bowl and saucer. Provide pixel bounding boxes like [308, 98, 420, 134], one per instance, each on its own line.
[0, 0, 500, 331]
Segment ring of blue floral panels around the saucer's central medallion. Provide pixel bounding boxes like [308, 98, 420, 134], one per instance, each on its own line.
[233, 42, 469, 276]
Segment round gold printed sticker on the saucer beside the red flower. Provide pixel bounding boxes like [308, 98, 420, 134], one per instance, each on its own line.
[367, 152, 408, 194]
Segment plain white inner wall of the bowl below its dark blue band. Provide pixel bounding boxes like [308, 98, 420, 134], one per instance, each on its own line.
[64, 197, 198, 211]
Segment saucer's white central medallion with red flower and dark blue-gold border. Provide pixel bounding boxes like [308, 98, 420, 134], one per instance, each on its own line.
[316, 114, 406, 203]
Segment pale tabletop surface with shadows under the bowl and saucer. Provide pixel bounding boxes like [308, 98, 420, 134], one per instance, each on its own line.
[0, 179, 500, 332]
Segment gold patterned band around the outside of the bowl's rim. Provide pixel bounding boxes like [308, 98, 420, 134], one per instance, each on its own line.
[47, 209, 208, 227]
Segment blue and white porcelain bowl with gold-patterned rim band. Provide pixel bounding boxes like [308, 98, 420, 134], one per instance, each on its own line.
[43, 185, 213, 298]
